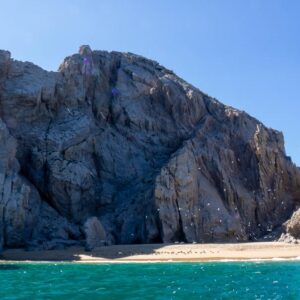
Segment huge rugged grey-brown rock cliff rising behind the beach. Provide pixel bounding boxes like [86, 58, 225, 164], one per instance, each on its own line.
[0, 46, 300, 248]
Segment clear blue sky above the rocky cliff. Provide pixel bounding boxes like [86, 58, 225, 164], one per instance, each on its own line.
[0, 0, 300, 165]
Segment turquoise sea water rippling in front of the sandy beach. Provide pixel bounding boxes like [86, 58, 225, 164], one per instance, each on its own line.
[0, 261, 300, 300]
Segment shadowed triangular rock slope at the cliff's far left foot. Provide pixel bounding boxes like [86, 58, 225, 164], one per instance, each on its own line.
[0, 117, 80, 248]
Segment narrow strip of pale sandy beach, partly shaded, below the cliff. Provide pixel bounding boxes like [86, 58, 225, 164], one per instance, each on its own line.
[1, 242, 300, 263]
